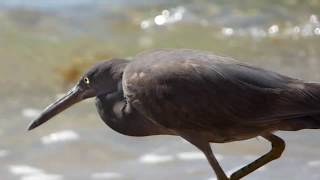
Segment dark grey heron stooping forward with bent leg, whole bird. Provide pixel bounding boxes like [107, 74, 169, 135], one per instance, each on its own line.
[29, 49, 320, 180]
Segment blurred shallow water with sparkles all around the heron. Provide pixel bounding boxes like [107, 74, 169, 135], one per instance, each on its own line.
[0, 0, 320, 180]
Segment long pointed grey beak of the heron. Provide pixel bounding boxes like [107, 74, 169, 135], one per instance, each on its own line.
[28, 85, 85, 130]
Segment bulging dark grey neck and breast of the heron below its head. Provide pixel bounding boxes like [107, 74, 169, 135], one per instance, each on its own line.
[96, 86, 163, 136]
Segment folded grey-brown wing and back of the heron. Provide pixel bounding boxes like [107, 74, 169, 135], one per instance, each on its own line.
[123, 49, 320, 142]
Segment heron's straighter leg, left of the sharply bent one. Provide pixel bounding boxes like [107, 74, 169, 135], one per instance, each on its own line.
[182, 136, 229, 180]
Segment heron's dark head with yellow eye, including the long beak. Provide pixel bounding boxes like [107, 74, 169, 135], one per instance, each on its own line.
[28, 59, 127, 130]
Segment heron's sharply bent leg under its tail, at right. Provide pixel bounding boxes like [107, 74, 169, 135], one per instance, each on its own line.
[230, 134, 285, 180]
